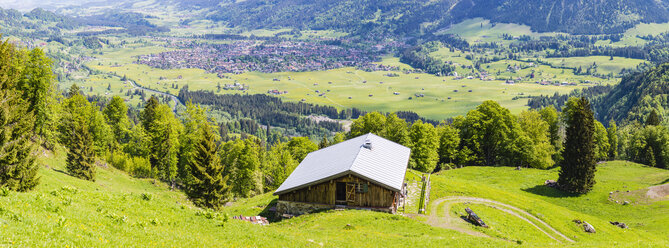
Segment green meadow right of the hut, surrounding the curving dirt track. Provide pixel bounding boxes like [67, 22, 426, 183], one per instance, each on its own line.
[430, 161, 669, 246]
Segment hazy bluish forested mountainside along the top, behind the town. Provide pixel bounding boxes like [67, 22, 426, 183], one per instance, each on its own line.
[209, 0, 669, 34]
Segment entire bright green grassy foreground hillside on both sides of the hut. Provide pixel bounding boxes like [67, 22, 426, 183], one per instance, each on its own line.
[0, 144, 669, 247]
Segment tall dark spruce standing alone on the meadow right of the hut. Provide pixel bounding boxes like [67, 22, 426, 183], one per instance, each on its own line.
[558, 97, 597, 194]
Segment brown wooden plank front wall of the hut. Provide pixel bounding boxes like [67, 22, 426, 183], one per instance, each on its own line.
[279, 175, 395, 207]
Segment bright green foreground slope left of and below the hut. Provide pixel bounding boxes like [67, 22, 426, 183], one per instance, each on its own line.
[0, 147, 500, 247]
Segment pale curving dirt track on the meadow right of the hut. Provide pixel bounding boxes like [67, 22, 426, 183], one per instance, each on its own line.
[427, 196, 574, 243]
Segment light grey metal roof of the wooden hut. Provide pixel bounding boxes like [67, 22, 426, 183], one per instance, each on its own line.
[274, 133, 411, 195]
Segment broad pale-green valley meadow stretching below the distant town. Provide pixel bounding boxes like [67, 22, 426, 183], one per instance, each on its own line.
[81, 45, 604, 119]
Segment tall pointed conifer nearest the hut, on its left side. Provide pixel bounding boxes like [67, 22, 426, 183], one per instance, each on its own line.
[186, 126, 229, 209]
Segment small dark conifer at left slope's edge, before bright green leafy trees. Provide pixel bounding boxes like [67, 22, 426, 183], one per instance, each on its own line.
[67, 122, 95, 181]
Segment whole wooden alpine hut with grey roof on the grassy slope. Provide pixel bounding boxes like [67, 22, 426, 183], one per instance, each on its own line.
[274, 133, 411, 215]
